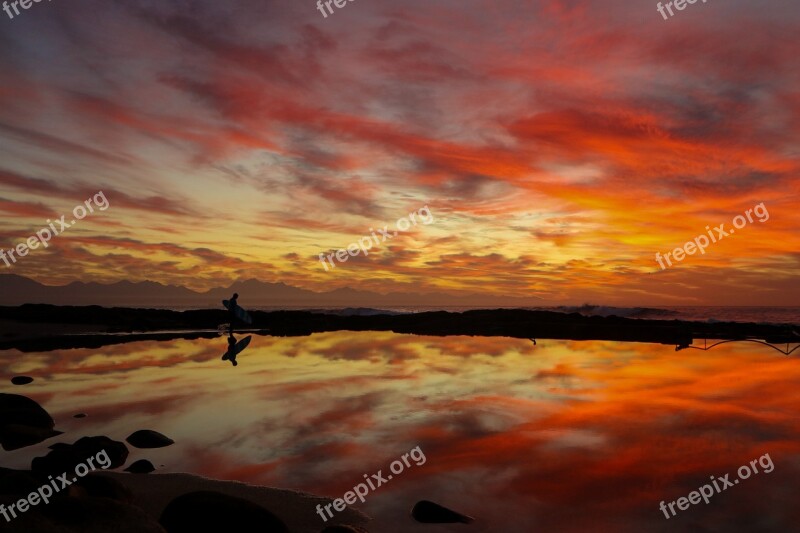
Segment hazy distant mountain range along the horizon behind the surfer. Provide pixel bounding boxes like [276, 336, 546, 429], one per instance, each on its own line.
[0, 274, 541, 309]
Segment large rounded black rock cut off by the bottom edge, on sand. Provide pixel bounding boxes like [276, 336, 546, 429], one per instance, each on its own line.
[160, 491, 289, 533]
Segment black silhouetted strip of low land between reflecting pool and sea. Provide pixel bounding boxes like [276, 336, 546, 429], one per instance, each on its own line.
[0, 304, 800, 351]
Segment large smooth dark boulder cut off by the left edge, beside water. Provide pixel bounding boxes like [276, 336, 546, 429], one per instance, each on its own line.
[0, 394, 61, 451]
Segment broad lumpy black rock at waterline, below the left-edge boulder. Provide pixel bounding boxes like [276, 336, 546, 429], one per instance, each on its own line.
[31, 436, 128, 475]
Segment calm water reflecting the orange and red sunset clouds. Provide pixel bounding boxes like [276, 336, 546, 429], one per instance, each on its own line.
[0, 331, 800, 533]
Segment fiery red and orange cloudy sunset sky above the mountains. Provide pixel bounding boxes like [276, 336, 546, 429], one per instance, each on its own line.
[0, 0, 800, 305]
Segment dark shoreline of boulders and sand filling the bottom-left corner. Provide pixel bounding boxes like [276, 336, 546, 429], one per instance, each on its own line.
[0, 393, 369, 533]
